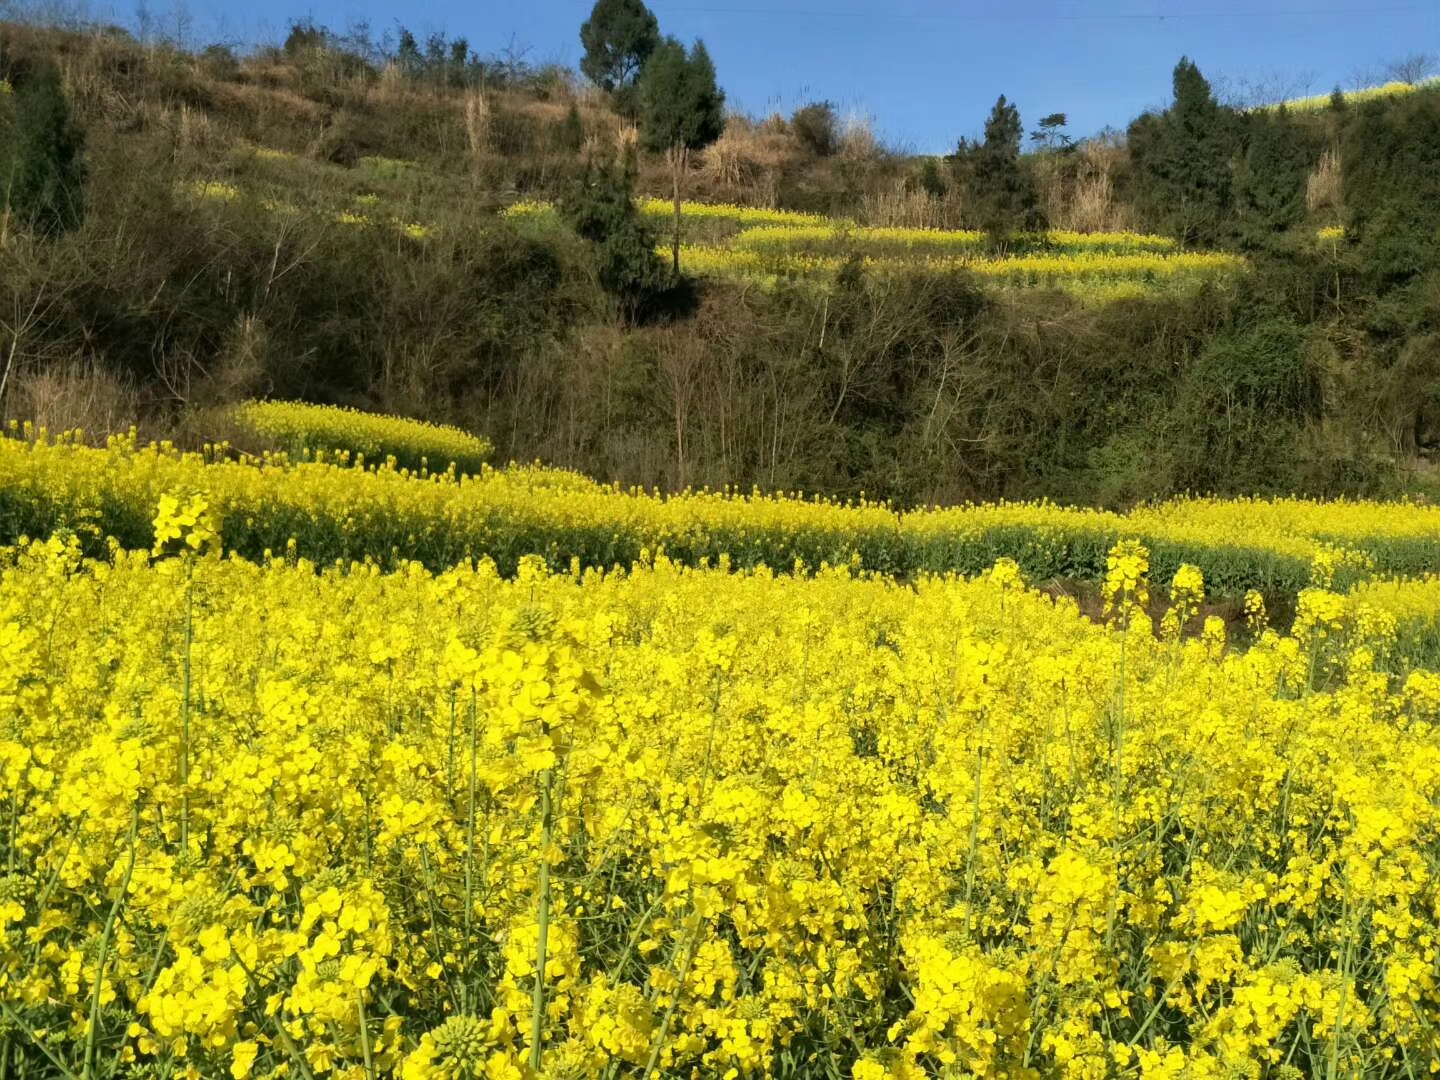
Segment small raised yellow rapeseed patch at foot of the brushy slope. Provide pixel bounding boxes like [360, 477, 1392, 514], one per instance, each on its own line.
[230, 402, 491, 472]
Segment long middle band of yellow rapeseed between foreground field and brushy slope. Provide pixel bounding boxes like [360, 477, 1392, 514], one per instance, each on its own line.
[8, 426, 1440, 603]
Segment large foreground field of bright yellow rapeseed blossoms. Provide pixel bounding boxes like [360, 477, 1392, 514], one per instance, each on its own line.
[0, 529, 1440, 1080]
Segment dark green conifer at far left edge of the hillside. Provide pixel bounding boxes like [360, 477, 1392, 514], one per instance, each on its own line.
[0, 62, 85, 236]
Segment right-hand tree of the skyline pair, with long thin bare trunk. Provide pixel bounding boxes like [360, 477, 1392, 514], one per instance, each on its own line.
[639, 37, 724, 274]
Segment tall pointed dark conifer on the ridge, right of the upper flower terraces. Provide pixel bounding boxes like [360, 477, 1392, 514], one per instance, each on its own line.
[1129, 58, 1236, 246]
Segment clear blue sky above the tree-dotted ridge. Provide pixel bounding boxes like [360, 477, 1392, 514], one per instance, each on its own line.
[84, 0, 1440, 153]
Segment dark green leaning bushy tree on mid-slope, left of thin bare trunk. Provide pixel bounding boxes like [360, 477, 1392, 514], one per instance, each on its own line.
[560, 161, 671, 323]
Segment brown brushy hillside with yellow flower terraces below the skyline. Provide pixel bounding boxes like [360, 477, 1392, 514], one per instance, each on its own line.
[0, 16, 1440, 505]
